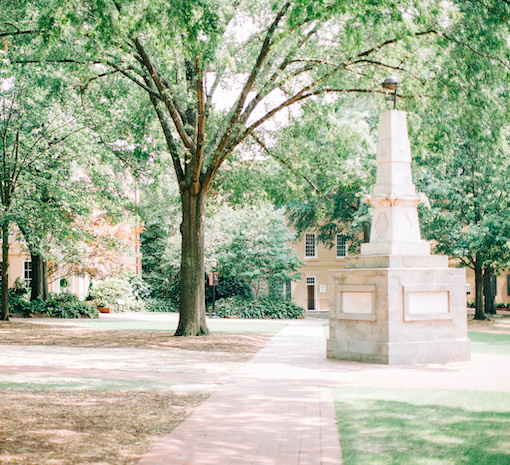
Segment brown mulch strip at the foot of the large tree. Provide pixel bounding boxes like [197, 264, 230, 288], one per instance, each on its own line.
[0, 321, 271, 360]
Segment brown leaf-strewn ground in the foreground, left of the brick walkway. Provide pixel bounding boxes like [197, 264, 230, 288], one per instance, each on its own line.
[0, 390, 207, 465]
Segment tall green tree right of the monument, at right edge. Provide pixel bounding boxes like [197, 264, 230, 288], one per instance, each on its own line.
[407, 2, 510, 319]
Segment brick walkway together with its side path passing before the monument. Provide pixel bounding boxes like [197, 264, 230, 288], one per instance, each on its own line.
[138, 320, 510, 465]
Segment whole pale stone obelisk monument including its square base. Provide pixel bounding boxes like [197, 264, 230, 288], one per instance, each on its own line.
[327, 110, 470, 364]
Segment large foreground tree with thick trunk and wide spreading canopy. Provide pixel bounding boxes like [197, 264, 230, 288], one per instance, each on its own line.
[8, 0, 510, 335]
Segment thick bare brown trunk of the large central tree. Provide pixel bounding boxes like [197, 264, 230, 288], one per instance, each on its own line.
[175, 188, 209, 336]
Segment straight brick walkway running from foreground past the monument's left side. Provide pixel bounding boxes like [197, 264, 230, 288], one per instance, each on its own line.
[138, 321, 342, 465]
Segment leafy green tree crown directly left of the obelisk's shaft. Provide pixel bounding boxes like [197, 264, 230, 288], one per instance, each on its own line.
[241, 98, 377, 252]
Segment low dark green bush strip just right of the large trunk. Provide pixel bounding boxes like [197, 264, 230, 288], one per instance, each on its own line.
[215, 297, 305, 319]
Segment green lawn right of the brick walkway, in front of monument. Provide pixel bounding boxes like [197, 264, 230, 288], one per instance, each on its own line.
[334, 388, 510, 465]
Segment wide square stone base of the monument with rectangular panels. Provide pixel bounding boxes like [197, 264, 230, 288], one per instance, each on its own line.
[327, 256, 471, 364]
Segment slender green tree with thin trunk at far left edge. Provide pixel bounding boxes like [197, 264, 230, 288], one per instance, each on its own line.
[0, 69, 85, 320]
